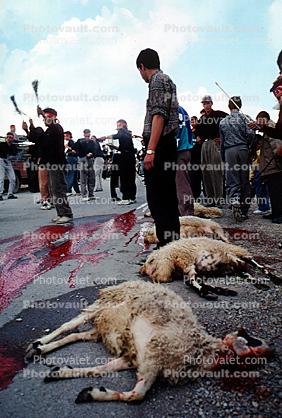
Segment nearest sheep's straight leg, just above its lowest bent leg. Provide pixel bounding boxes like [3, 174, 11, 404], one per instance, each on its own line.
[44, 357, 131, 382]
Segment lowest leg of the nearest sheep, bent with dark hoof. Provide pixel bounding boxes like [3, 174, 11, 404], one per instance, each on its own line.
[75, 373, 156, 403]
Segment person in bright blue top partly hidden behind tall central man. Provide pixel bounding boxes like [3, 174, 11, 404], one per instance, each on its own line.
[176, 106, 194, 216]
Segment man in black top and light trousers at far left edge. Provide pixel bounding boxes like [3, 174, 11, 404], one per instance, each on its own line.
[0, 132, 17, 200]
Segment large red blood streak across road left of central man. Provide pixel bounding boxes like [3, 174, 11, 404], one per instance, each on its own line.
[0, 211, 136, 311]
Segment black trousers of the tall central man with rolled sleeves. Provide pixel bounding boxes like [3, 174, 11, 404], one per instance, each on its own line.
[144, 132, 180, 246]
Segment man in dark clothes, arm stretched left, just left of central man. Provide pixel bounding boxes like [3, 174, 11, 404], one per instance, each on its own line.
[101, 119, 136, 205]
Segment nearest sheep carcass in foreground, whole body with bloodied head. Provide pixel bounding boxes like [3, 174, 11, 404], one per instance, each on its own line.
[27, 281, 269, 403]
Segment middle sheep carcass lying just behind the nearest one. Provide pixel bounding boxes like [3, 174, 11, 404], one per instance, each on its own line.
[140, 237, 276, 297]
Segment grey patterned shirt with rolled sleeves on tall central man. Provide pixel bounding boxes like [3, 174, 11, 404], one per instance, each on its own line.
[143, 70, 179, 141]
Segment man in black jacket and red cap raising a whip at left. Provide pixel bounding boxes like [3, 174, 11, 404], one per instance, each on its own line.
[38, 106, 73, 224]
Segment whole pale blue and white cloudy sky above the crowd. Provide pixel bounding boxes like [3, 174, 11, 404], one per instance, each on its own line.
[0, 0, 282, 139]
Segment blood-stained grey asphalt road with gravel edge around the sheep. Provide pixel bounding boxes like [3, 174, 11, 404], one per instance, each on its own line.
[0, 180, 282, 418]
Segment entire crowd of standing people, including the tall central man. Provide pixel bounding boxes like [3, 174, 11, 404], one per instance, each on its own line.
[0, 49, 282, 233]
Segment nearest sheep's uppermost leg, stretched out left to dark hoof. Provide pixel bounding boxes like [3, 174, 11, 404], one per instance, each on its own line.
[26, 312, 94, 358]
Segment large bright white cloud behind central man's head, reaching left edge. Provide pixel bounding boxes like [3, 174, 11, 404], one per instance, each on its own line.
[0, 0, 229, 138]
